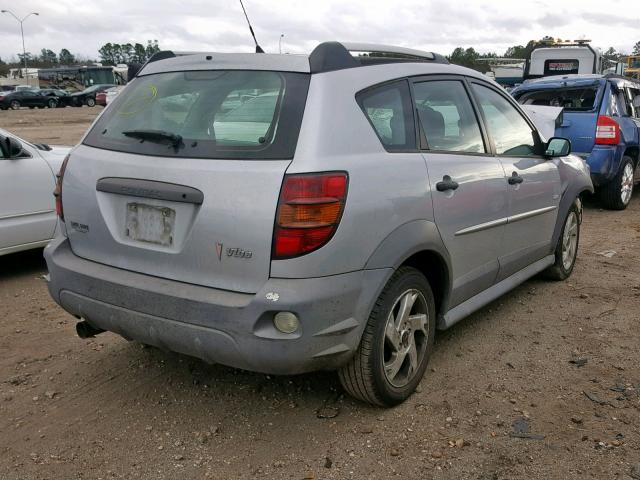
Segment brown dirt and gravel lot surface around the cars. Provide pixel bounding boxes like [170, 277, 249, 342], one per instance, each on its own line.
[0, 108, 640, 480]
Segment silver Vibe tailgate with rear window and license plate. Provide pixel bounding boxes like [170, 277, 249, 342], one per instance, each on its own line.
[62, 67, 308, 293]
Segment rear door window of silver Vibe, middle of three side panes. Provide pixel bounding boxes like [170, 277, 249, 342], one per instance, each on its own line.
[414, 80, 486, 153]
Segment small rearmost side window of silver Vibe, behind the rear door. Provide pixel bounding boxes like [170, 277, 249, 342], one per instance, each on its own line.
[356, 80, 416, 152]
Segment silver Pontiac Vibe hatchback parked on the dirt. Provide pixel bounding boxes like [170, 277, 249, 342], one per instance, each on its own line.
[45, 42, 593, 405]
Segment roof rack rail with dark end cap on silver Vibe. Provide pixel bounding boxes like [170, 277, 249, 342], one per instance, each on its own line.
[309, 42, 449, 73]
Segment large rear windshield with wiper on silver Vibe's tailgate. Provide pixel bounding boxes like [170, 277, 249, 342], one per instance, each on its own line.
[84, 70, 309, 159]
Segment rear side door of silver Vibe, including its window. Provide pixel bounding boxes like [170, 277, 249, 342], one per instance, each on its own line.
[413, 77, 507, 306]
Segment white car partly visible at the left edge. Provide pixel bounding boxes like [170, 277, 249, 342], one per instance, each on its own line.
[0, 129, 71, 256]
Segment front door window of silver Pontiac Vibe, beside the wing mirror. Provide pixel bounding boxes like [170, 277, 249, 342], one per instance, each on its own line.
[472, 83, 539, 156]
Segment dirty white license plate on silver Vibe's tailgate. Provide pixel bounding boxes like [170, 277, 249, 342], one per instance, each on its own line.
[126, 203, 176, 246]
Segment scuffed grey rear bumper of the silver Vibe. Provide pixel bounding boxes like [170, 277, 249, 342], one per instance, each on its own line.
[45, 238, 392, 375]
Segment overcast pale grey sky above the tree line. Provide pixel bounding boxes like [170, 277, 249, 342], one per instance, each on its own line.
[0, 0, 640, 59]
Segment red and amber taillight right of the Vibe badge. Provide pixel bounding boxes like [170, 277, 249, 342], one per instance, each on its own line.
[273, 172, 348, 260]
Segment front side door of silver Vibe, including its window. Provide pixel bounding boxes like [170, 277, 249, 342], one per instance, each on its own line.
[472, 82, 561, 280]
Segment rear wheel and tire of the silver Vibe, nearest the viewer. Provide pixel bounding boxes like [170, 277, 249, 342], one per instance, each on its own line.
[338, 267, 436, 407]
